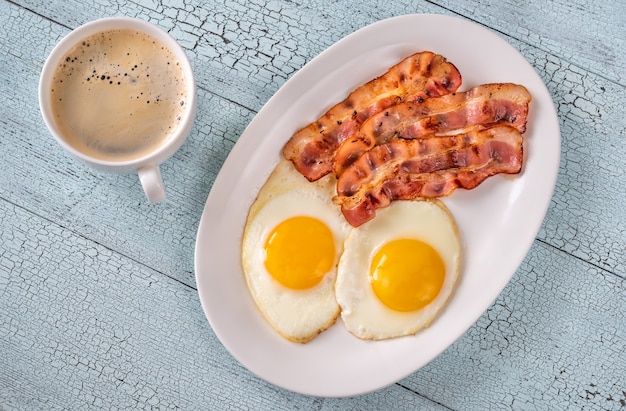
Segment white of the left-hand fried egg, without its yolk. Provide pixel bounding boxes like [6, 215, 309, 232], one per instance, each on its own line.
[242, 161, 349, 343]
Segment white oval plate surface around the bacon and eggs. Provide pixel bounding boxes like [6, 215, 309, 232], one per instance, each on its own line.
[195, 15, 561, 397]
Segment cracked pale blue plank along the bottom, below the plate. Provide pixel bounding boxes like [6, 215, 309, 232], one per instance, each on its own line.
[0, 196, 626, 409]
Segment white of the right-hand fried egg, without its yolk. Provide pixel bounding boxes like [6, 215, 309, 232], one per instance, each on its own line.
[335, 200, 460, 340]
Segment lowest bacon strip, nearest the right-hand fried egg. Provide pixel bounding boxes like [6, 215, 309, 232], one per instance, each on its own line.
[334, 125, 523, 227]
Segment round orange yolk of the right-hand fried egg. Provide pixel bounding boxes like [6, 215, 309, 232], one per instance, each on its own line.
[370, 239, 446, 311]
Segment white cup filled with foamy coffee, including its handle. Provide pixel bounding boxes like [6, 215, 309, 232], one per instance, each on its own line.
[39, 17, 196, 203]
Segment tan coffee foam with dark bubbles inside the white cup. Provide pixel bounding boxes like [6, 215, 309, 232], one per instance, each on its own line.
[51, 30, 186, 161]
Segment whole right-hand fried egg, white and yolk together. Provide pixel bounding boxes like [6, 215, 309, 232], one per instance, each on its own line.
[335, 200, 460, 340]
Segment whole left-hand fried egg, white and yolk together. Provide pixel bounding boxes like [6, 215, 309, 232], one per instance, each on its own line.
[242, 161, 349, 343]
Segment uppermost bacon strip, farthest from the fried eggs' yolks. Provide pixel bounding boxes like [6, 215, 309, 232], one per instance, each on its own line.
[283, 51, 461, 181]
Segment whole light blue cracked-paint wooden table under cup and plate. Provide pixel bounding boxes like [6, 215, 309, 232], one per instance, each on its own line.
[0, 0, 626, 410]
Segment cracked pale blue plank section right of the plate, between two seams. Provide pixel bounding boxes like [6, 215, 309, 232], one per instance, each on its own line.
[518, 39, 626, 278]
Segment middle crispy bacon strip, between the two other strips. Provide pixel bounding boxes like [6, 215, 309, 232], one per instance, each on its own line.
[334, 83, 531, 176]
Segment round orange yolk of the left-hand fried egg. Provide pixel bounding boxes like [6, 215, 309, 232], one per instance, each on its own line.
[265, 216, 335, 290]
